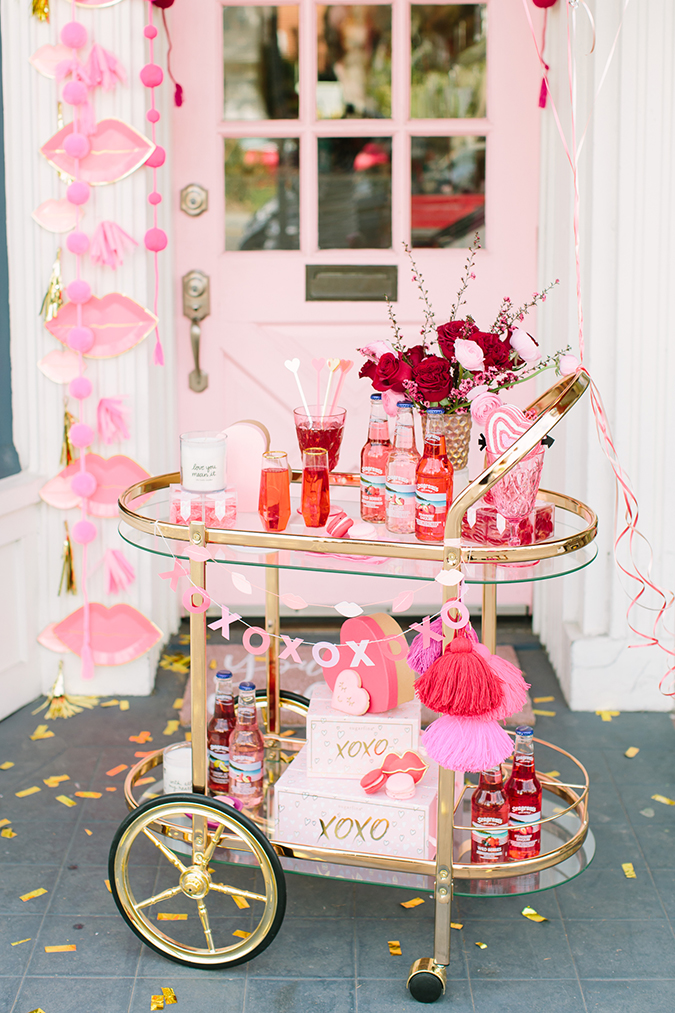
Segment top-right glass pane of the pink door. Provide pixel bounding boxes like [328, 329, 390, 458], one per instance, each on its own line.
[410, 3, 486, 120]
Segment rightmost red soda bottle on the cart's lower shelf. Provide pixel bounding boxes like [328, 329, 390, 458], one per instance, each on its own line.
[506, 724, 541, 861]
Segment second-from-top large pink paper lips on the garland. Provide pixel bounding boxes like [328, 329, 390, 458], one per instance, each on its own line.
[45, 292, 157, 359]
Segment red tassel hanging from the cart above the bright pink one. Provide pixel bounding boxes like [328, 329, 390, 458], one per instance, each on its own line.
[415, 636, 504, 717]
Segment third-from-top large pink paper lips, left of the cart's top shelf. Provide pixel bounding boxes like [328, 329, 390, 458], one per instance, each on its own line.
[40, 454, 150, 517]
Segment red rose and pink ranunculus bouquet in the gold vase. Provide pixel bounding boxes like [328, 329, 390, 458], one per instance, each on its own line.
[359, 234, 579, 421]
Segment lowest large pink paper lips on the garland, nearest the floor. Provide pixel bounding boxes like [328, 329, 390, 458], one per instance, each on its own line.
[54, 602, 162, 665]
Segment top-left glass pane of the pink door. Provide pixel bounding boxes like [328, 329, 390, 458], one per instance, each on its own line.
[223, 6, 298, 120]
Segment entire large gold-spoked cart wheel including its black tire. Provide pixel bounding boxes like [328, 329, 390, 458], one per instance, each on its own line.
[108, 794, 286, 967]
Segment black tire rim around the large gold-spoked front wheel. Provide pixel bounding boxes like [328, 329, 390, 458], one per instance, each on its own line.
[107, 792, 286, 970]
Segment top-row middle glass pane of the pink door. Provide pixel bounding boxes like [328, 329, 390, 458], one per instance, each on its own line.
[316, 4, 391, 120]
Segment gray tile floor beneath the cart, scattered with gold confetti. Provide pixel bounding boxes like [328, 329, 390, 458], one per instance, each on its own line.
[0, 620, 675, 1013]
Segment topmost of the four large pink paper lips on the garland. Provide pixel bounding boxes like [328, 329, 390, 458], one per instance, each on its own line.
[40, 120, 155, 186]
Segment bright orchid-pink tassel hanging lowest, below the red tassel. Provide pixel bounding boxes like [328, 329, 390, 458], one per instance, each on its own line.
[422, 714, 513, 771]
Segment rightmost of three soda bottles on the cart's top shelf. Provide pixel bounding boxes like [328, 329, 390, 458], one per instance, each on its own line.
[415, 408, 453, 542]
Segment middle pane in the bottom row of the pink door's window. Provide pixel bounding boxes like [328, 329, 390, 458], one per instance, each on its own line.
[318, 137, 391, 249]
